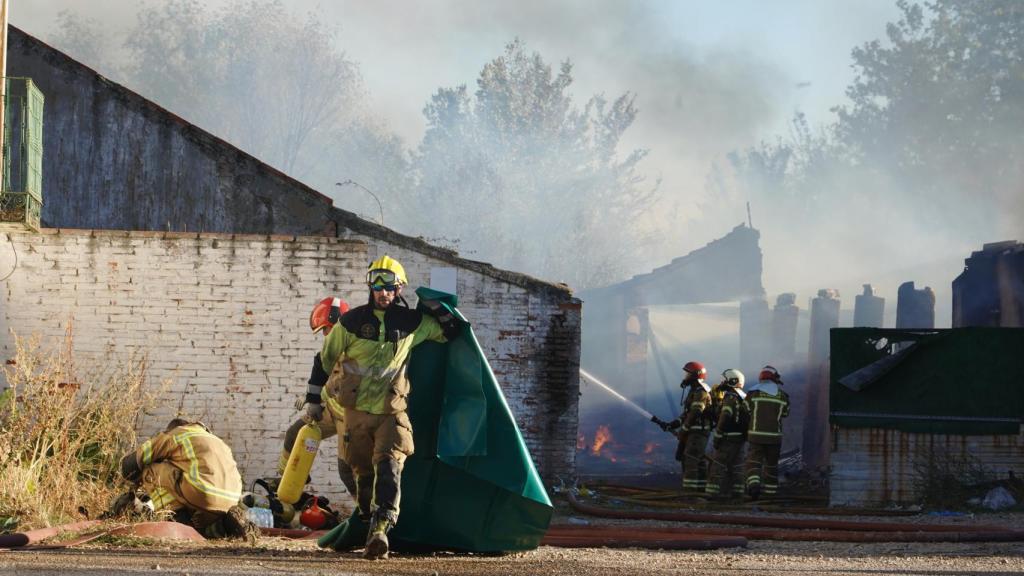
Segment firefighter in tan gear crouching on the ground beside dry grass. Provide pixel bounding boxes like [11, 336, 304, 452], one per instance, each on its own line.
[112, 418, 251, 541]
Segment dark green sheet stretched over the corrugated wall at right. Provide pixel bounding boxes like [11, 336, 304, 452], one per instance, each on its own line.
[829, 328, 1024, 435]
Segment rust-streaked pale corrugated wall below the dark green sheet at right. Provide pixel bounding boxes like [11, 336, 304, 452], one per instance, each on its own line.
[829, 428, 1024, 506]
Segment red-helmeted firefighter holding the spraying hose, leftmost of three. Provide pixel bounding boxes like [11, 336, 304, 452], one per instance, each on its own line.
[652, 362, 712, 496]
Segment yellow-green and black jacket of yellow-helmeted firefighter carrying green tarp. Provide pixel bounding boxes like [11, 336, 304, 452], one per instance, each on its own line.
[321, 304, 446, 414]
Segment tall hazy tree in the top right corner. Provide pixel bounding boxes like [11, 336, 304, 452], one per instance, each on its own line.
[837, 0, 1024, 230]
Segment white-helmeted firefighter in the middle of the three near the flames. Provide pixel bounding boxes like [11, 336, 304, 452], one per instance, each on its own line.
[706, 368, 750, 499]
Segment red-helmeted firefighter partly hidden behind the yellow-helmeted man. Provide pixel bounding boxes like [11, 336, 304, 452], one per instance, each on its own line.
[273, 296, 355, 498]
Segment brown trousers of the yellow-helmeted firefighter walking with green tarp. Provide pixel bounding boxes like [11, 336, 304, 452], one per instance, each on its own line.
[341, 408, 414, 525]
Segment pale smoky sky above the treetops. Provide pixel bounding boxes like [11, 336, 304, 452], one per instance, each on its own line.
[10, 0, 897, 155]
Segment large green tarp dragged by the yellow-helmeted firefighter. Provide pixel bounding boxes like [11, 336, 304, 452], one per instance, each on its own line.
[319, 288, 552, 552]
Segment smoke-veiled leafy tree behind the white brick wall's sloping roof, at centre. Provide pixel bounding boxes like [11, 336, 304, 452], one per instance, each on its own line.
[414, 39, 655, 288]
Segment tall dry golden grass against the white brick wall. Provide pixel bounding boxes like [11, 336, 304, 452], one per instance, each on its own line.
[0, 331, 165, 530]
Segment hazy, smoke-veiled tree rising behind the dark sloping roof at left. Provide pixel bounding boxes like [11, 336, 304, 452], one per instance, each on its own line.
[48, 0, 409, 206]
